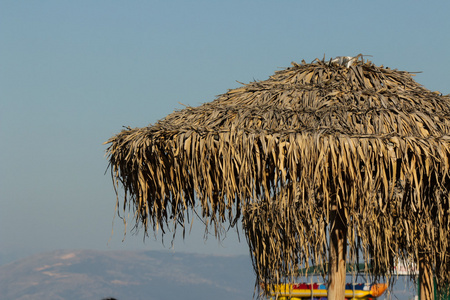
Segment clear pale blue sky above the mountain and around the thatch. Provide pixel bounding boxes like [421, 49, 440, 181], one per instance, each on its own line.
[0, 0, 450, 298]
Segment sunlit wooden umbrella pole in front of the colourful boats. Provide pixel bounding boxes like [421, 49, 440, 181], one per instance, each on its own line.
[328, 205, 347, 300]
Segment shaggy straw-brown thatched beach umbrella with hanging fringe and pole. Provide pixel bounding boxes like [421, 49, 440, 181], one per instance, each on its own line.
[107, 56, 450, 299]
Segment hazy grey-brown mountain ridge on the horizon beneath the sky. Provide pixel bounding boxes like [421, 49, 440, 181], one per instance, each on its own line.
[0, 250, 255, 300]
